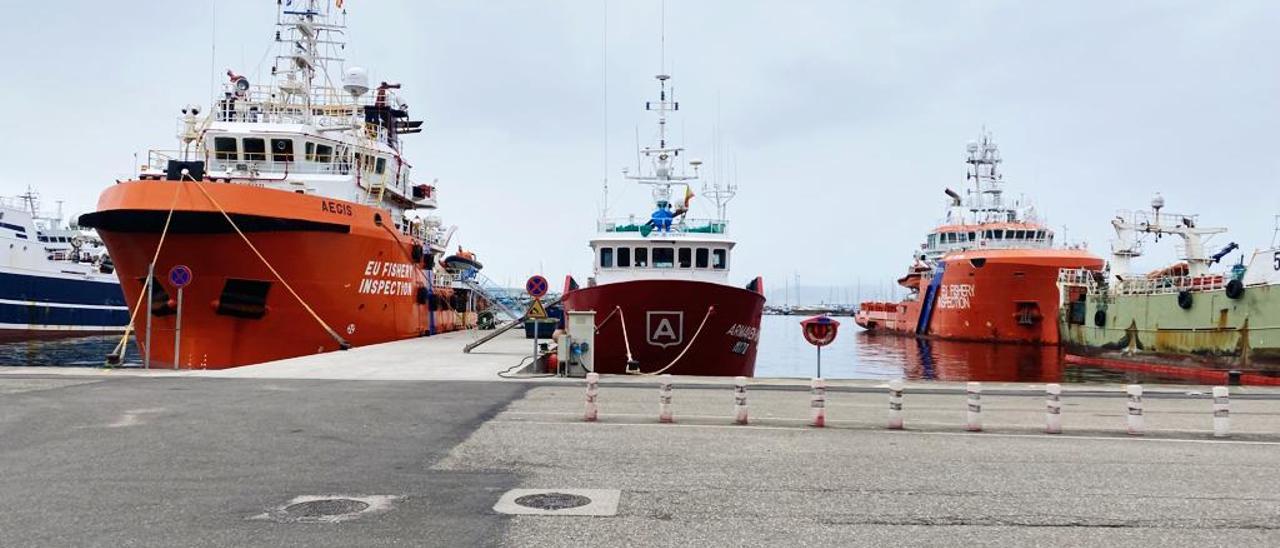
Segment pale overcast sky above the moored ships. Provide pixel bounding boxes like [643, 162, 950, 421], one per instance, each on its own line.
[0, 0, 1280, 299]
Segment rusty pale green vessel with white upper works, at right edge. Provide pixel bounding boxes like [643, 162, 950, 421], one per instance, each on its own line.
[1059, 195, 1280, 371]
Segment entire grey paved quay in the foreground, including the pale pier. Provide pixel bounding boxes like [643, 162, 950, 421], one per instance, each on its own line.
[0, 327, 1280, 547]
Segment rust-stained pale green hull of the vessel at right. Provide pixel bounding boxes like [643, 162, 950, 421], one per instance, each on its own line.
[1059, 284, 1280, 370]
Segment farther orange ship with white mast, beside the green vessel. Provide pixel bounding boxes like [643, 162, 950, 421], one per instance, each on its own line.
[855, 132, 1103, 344]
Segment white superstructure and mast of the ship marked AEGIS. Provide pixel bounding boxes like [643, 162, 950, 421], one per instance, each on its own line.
[140, 0, 449, 251]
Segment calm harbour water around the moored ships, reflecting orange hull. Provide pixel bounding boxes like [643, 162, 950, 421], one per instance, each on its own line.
[0, 315, 1269, 384]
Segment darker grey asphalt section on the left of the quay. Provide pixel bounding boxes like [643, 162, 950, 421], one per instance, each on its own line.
[0, 378, 525, 547]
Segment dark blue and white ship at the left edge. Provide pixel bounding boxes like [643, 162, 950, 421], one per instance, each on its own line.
[0, 191, 129, 341]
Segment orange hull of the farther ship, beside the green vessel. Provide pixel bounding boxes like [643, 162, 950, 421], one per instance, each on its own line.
[855, 250, 1103, 344]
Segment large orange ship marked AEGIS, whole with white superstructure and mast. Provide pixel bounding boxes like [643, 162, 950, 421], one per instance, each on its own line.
[79, 0, 479, 369]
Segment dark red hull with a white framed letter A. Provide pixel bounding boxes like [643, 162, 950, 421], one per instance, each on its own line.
[564, 280, 764, 376]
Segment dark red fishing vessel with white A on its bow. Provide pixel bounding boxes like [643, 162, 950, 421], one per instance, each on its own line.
[564, 74, 764, 376]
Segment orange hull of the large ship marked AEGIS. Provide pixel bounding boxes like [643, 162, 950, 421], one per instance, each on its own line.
[81, 182, 474, 369]
